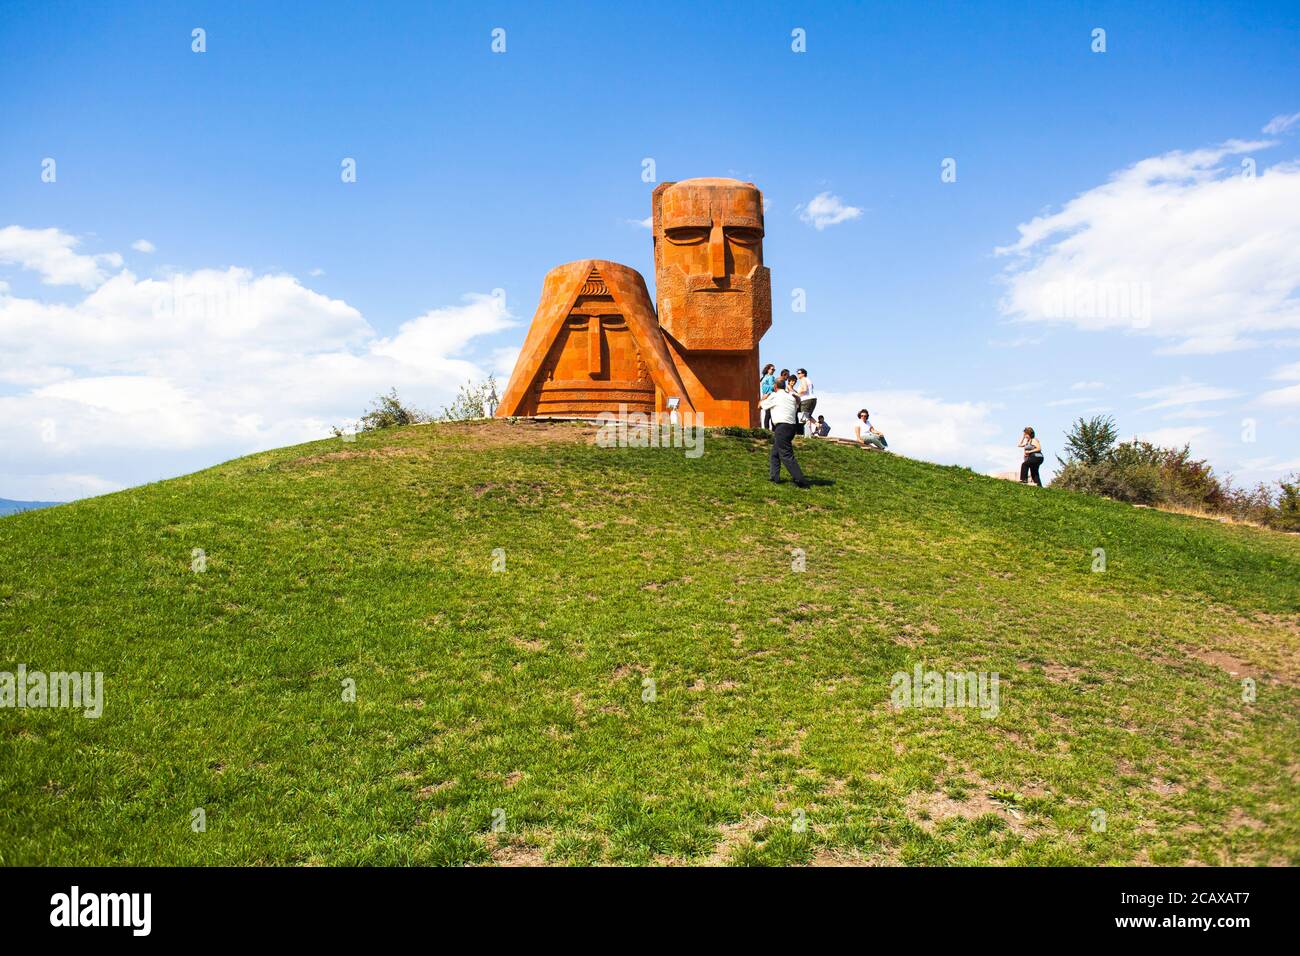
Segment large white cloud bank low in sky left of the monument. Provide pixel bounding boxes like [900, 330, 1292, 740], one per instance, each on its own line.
[0, 225, 515, 499]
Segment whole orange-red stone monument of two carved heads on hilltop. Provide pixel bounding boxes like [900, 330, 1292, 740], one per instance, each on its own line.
[497, 179, 772, 427]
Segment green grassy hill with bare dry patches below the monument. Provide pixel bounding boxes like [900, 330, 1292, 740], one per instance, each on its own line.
[0, 421, 1300, 865]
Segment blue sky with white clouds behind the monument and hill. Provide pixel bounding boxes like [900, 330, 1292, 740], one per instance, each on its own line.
[0, 0, 1300, 498]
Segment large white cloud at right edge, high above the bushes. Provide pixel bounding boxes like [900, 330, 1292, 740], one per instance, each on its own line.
[996, 140, 1300, 354]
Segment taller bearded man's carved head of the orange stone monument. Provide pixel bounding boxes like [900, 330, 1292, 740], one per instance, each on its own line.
[654, 179, 772, 351]
